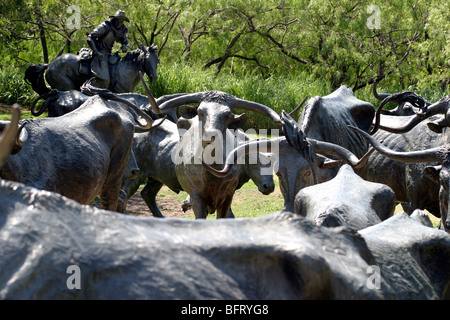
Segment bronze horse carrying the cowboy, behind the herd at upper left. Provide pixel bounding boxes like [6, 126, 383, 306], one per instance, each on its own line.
[25, 45, 159, 96]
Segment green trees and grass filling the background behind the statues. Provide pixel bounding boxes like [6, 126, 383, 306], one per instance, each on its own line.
[0, 0, 450, 115]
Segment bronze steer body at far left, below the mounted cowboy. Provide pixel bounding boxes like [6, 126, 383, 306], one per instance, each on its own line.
[0, 96, 141, 211]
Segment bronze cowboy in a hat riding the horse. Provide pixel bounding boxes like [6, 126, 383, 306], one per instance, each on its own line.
[87, 10, 130, 89]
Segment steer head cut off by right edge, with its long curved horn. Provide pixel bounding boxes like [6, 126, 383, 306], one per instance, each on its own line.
[349, 126, 450, 233]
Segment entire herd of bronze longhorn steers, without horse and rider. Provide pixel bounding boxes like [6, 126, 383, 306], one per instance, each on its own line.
[0, 53, 450, 299]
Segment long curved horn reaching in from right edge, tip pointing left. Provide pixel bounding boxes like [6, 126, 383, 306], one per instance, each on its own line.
[348, 126, 442, 163]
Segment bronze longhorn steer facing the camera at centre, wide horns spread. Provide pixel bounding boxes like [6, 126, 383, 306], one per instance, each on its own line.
[149, 91, 279, 218]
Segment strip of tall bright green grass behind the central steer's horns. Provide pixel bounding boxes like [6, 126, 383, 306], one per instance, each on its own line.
[142, 63, 331, 129]
